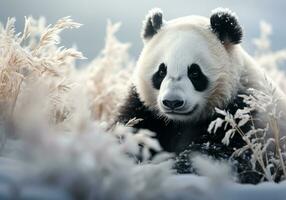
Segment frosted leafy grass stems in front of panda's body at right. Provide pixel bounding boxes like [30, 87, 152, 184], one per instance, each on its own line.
[209, 86, 286, 181]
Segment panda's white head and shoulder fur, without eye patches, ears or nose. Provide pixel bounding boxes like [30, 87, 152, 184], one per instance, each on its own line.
[134, 16, 259, 120]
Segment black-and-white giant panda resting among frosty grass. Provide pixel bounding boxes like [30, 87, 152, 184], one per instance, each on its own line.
[117, 8, 286, 166]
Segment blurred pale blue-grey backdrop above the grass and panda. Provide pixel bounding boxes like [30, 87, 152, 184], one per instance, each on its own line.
[0, 0, 286, 63]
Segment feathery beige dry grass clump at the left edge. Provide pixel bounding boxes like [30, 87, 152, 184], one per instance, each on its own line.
[0, 17, 84, 130]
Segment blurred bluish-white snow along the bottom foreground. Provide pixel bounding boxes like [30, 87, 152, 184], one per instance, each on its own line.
[0, 141, 286, 200]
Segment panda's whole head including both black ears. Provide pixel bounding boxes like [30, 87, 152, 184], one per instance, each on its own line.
[135, 9, 242, 122]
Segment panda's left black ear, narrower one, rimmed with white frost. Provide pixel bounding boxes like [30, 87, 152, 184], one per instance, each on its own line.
[141, 8, 163, 40]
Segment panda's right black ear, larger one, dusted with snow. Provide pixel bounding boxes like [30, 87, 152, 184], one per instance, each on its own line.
[210, 8, 243, 44]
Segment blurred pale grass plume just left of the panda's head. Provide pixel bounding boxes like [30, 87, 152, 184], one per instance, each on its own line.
[85, 21, 134, 122]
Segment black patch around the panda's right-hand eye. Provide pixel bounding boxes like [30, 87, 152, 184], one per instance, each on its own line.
[188, 63, 209, 92]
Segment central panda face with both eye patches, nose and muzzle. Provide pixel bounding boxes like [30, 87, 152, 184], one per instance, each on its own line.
[152, 63, 209, 120]
